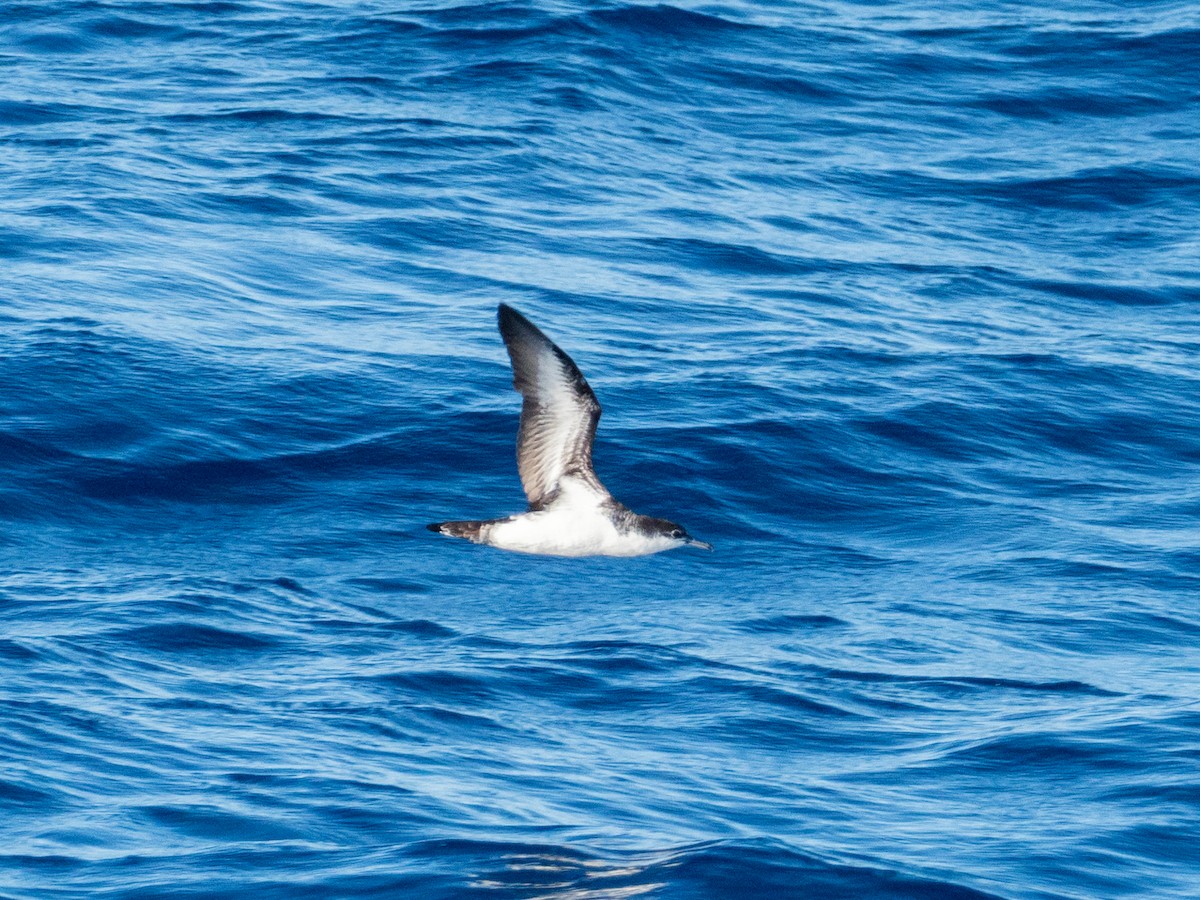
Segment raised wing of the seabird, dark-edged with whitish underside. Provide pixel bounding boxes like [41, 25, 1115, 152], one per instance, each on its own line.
[497, 304, 608, 509]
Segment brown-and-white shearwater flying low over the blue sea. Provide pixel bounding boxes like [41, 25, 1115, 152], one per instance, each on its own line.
[428, 304, 713, 557]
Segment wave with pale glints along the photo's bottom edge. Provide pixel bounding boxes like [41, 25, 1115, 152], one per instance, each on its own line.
[0, 840, 998, 900]
